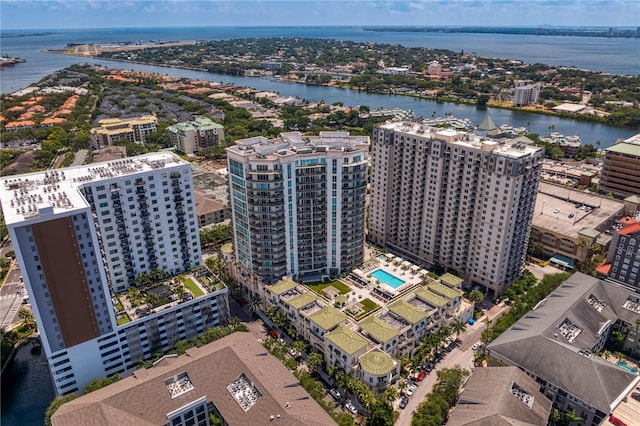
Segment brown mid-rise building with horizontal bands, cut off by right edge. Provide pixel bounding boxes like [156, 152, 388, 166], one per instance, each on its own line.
[598, 133, 640, 198]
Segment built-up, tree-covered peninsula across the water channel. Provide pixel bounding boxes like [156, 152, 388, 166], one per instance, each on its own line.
[53, 37, 640, 127]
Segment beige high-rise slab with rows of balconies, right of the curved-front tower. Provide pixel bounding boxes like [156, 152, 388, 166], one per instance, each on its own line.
[368, 122, 543, 295]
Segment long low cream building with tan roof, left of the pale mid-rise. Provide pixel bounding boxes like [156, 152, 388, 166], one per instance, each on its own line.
[90, 115, 158, 148]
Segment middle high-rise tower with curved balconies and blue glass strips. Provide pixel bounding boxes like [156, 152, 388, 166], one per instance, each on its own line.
[227, 132, 369, 283]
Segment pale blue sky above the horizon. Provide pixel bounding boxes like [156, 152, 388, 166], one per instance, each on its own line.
[0, 0, 640, 29]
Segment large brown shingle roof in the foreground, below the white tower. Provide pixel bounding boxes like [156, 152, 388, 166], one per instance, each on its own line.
[52, 332, 335, 426]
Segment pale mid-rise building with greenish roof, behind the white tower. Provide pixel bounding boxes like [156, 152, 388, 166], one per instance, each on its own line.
[167, 117, 224, 154]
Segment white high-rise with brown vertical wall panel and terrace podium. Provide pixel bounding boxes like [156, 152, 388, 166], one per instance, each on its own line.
[0, 153, 228, 394]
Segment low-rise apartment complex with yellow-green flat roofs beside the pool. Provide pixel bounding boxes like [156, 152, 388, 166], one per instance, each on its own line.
[265, 256, 462, 393]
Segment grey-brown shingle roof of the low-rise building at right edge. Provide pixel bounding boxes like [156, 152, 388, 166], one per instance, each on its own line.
[489, 272, 640, 413]
